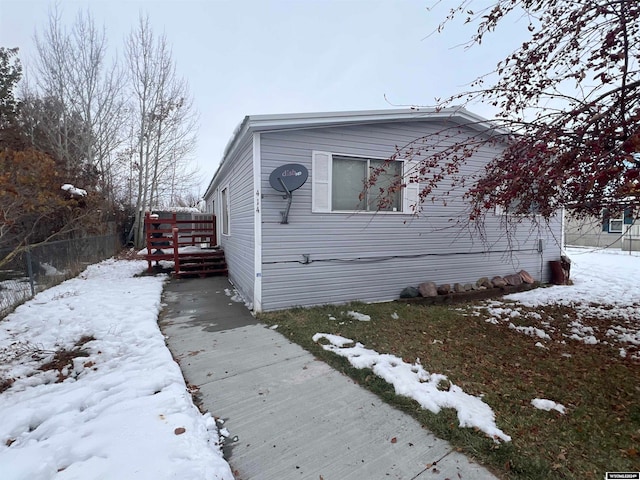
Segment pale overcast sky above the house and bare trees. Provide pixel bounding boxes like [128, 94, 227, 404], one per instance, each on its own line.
[0, 0, 526, 188]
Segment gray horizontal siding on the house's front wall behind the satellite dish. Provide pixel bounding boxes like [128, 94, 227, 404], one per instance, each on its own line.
[261, 121, 561, 310]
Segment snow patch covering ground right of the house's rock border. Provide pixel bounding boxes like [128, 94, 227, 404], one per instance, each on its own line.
[477, 248, 640, 360]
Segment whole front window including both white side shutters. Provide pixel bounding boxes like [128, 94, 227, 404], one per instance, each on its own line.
[311, 151, 420, 214]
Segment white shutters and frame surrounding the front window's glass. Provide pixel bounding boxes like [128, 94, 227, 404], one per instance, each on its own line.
[311, 151, 420, 215]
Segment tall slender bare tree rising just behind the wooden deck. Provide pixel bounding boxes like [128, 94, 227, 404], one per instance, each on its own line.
[125, 16, 197, 246]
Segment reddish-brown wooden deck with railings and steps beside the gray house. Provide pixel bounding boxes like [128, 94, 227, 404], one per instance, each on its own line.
[144, 212, 227, 278]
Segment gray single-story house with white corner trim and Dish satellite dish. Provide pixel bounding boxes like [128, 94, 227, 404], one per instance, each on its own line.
[204, 109, 562, 311]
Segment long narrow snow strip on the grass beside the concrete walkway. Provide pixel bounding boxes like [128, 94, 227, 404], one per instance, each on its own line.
[313, 333, 511, 442]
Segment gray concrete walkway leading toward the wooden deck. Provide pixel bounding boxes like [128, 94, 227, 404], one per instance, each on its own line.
[160, 277, 496, 480]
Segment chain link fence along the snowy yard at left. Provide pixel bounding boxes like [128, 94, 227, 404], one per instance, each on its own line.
[0, 235, 121, 319]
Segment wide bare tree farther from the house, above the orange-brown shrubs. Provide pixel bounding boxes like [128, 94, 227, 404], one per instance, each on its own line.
[31, 7, 125, 201]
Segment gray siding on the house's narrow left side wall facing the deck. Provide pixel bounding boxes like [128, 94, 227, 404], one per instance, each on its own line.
[206, 137, 255, 302]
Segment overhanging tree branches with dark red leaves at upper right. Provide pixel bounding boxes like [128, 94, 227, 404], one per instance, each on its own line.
[369, 0, 640, 220]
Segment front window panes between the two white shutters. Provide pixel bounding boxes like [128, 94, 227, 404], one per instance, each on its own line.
[331, 155, 402, 212]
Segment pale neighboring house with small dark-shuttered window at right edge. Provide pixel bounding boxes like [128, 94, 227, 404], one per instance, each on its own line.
[564, 208, 640, 251]
